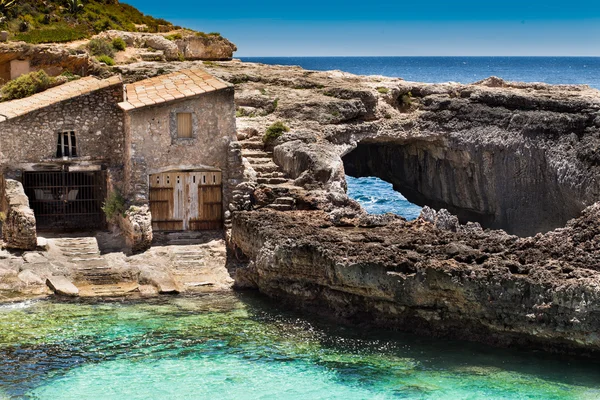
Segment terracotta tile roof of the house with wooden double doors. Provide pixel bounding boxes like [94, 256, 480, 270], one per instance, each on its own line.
[119, 69, 231, 111]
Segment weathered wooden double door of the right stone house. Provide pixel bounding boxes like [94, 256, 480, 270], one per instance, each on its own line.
[150, 171, 223, 231]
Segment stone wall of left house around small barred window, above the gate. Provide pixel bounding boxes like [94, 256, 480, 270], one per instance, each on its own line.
[0, 83, 125, 186]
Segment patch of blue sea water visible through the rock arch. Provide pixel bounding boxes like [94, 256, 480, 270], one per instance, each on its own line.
[346, 175, 421, 221]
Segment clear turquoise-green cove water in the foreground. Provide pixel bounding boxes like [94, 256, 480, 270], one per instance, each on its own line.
[0, 294, 600, 400]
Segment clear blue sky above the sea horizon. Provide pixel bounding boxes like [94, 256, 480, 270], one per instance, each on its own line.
[123, 0, 600, 57]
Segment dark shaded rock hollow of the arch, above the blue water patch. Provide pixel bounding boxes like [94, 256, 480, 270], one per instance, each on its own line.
[342, 140, 584, 236]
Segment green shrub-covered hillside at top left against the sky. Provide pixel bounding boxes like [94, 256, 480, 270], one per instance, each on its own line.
[0, 0, 179, 43]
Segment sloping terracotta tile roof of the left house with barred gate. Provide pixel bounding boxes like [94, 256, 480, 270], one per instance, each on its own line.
[0, 76, 121, 122]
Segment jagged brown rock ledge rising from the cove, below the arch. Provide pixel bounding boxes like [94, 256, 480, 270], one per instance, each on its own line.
[232, 204, 600, 354]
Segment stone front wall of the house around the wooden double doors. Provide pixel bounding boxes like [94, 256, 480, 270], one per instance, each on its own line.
[125, 88, 235, 205]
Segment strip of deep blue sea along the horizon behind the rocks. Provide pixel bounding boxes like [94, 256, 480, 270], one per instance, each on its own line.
[241, 57, 600, 89]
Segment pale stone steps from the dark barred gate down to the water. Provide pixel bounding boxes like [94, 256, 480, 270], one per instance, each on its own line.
[51, 237, 138, 296]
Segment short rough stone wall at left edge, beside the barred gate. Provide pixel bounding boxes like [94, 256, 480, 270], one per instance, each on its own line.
[2, 179, 37, 250]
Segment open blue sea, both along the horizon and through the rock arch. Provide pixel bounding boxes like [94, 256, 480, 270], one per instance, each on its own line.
[241, 57, 600, 220]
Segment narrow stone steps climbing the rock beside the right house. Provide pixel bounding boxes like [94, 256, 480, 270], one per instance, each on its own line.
[240, 136, 295, 211]
